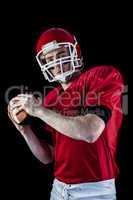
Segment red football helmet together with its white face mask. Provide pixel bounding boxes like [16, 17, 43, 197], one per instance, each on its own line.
[36, 28, 82, 82]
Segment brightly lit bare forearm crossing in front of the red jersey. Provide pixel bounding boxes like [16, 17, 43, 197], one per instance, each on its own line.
[37, 108, 105, 142]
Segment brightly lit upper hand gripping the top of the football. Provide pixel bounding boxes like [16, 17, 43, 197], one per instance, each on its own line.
[10, 94, 42, 117]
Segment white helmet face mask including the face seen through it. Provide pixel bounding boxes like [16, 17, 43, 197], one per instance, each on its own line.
[36, 41, 82, 82]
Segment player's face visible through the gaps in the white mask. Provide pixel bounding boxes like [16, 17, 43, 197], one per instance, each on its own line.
[45, 47, 70, 76]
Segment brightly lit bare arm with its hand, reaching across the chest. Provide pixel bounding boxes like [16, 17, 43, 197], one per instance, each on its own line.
[10, 95, 110, 143]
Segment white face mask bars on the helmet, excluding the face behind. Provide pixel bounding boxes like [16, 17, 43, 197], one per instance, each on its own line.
[36, 42, 82, 82]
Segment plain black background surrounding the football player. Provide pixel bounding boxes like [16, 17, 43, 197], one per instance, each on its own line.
[0, 4, 130, 200]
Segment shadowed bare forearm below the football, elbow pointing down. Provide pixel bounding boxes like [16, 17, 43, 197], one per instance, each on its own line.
[22, 128, 53, 164]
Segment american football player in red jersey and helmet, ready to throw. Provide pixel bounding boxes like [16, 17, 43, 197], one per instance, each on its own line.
[9, 28, 123, 200]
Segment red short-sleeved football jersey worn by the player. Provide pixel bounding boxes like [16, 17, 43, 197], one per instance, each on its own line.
[44, 66, 124, 183]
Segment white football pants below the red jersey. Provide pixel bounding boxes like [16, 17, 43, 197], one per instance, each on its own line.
[50, 179, 116, 200]
